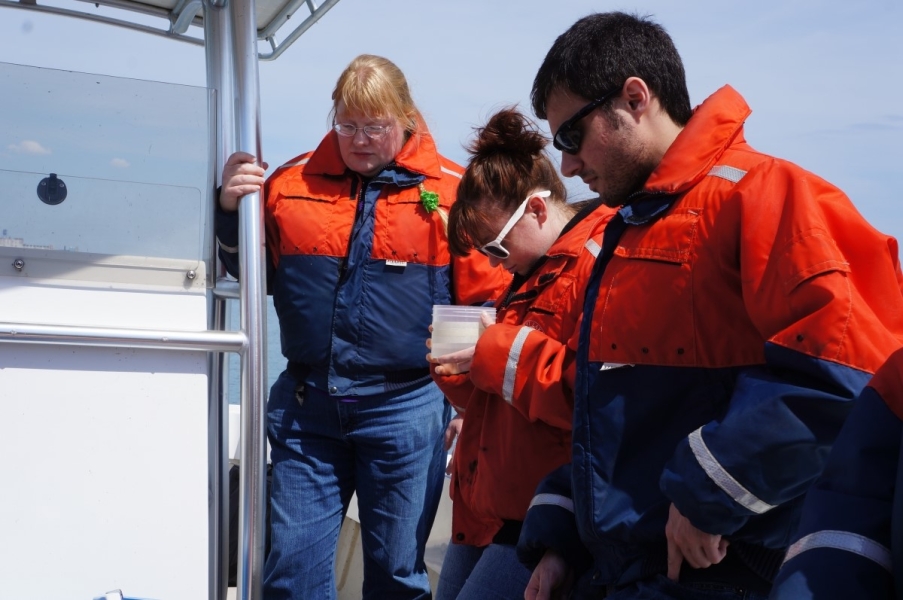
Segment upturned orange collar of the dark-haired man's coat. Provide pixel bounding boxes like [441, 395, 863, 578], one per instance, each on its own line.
[643, 85, 752, 194]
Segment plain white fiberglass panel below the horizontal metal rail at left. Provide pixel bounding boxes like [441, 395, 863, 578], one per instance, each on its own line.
[0, 345, 209, 600]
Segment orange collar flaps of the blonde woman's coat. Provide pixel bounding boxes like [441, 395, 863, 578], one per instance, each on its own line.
[304, 122, 442, 179]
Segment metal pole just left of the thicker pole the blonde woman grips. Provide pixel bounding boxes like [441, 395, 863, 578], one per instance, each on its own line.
[204, 0, 235, 600]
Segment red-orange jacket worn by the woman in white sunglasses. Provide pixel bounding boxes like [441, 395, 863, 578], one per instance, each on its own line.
[433, 204, 614, 546]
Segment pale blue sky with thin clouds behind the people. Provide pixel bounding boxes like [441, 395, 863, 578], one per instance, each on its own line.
[0, 0, 903, 239]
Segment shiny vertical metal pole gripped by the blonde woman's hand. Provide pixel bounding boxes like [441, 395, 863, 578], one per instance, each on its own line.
[230, 0, 266, 600]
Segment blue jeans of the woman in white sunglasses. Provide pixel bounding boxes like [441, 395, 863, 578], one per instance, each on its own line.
[436, 543, 532, 600]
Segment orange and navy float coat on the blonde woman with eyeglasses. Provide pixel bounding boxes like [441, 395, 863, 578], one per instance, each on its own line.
[216, 127, 510, 396]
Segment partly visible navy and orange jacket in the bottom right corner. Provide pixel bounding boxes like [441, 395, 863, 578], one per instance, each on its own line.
[771, 351, 903, 600]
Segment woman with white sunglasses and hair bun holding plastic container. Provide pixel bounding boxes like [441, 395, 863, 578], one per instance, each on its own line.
[430, 109, 613, 600]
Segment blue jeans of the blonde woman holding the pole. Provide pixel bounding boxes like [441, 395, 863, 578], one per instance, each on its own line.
[264, 373, 451, 600]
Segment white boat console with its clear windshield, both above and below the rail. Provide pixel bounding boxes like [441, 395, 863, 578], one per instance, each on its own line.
[0, 63, 213, 600]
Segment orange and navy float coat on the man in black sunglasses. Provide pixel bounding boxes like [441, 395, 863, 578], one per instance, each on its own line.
[519, 86, 903, 585]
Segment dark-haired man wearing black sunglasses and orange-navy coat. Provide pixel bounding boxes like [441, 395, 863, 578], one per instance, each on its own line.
[518, 12, 903, 600]
